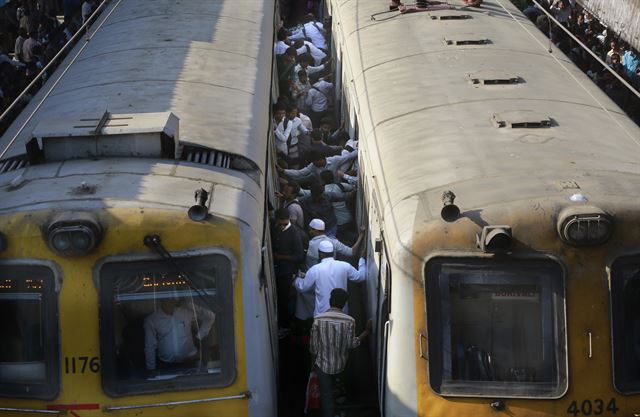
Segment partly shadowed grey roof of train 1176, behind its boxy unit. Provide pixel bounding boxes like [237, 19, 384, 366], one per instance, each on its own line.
[0, 0, 274, 172]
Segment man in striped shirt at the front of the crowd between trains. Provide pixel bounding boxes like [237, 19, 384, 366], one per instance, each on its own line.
[310, 288, 372, 417]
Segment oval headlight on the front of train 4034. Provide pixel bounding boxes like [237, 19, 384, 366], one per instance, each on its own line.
[557, 206, 613, 246]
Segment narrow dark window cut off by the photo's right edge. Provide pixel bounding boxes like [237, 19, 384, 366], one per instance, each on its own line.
[611, 257, 640, 394]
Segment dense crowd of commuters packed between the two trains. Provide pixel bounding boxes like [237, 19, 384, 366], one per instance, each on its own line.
[271, 1, 371, 417]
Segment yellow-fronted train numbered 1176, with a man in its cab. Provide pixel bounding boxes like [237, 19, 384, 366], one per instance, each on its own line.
[0, 0, 277, 417]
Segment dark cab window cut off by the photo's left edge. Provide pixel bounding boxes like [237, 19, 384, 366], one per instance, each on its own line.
[0, 265, 59, 399]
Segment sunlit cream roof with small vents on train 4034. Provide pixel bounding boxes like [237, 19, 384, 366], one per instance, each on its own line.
[331, 0, 640, 228]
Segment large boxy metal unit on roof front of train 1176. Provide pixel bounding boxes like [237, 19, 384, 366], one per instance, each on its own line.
[33, 112, 179, 162]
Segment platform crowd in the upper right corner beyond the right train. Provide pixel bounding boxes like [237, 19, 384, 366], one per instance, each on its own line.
[513, 0, 640, 124]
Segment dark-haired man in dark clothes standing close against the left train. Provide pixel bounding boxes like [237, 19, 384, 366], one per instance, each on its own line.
[271, 208, 304, 328]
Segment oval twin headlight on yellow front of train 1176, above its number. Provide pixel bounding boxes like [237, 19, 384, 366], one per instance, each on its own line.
[47, 213, 102, 256]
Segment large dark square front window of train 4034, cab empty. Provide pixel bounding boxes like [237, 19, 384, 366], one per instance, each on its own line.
[426, 259, 567, 398]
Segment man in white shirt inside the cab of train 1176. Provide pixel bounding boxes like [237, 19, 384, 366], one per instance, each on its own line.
[144, 297, 215, 377]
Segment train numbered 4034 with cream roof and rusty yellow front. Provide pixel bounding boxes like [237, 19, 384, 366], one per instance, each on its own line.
[328, 0, 640, 417]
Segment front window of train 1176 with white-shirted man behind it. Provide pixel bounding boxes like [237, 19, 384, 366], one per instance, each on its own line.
[99, 255, 235, 397]
